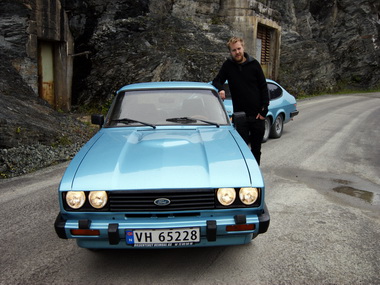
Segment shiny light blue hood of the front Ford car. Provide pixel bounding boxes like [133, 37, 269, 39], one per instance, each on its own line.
[60, 128, 263, 190]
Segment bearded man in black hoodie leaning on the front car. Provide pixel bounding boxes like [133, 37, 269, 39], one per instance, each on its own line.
[212, 37, 269, 165]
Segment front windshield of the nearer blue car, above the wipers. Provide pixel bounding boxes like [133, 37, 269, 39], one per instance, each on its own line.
[106, 89, 229, 127]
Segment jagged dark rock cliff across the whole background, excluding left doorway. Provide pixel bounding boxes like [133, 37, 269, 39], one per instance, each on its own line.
[0, 0, 380, 176]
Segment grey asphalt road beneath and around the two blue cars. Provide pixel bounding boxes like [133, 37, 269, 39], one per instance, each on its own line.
[0, 93, 380, 284]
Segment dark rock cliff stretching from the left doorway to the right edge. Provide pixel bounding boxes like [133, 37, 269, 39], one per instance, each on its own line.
[63, 0, 380, 104]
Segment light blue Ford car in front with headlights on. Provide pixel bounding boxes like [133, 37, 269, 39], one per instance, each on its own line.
[54, 82, 270, 249]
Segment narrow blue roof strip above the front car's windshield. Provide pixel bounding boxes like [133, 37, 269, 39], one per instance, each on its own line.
[117, 81, 216, 92]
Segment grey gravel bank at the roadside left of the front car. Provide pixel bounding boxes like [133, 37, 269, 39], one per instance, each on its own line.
[0, 113, 98, 179]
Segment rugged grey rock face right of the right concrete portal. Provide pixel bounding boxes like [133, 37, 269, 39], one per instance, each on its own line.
[267, 0, 380, 94]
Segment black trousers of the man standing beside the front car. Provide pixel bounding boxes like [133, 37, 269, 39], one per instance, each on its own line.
[236, 117, 265, 165]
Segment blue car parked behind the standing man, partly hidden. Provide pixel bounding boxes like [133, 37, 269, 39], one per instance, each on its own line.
[224, 79, 299, 142]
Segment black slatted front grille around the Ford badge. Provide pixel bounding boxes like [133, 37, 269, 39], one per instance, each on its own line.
[109, 189, 215, 212]
